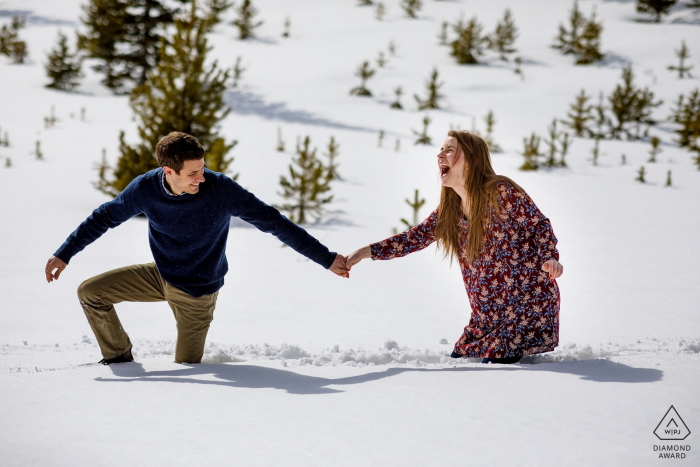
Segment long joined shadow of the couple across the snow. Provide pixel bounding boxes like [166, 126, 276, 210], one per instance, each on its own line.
[96, 360, 663, 394]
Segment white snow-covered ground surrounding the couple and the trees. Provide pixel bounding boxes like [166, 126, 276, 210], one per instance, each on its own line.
[0, 0, 700, 466]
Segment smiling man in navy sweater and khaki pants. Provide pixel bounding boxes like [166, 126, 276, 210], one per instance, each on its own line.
[45, 132, 348, 365]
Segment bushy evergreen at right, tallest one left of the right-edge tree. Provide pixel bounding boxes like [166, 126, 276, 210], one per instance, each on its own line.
[608, 65, 663, 139]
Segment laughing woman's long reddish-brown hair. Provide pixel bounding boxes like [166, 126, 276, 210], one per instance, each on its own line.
[435, 130, 523, 263]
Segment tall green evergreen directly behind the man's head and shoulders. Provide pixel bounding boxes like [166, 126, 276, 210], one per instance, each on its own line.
[97, 3, 237, 196]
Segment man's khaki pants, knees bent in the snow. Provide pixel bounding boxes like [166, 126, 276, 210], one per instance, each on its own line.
[78, 263, 219, 363]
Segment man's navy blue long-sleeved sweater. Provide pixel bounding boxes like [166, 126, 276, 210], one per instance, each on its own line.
[54, 168, 336, 297]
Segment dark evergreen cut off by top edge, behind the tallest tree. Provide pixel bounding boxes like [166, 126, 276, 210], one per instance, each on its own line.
[78, 0, 187, 93]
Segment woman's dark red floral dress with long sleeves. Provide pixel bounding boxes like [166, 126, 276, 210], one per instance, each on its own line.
[371, 183, 560, 358]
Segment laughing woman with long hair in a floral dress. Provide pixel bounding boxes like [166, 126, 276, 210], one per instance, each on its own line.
[347, 131, 564, 363]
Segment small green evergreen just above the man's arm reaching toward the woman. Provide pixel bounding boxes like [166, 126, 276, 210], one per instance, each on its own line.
[277, 136, 333, 224]
